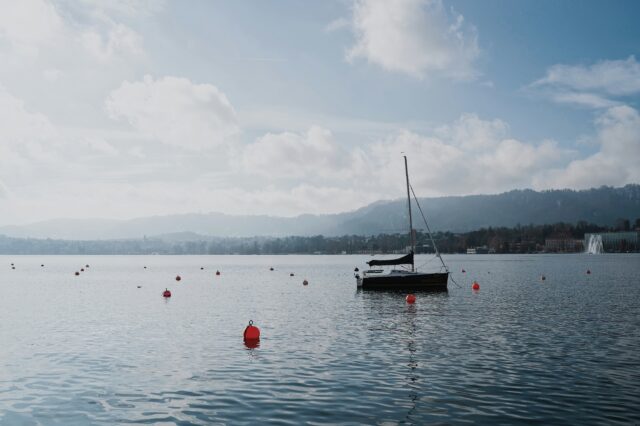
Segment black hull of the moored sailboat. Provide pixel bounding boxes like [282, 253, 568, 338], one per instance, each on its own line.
[358, 272, 449, 291]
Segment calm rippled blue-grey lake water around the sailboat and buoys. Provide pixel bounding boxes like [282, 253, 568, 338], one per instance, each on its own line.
[0, 255, 640, 425]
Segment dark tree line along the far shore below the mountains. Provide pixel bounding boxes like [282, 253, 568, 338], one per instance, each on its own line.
[0, 218, 640, 255]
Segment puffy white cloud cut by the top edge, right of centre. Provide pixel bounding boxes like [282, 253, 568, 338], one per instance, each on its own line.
[342, 0, 480, 80]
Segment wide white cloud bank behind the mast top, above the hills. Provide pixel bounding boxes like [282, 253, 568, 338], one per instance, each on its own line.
[369, 114, 569, 196]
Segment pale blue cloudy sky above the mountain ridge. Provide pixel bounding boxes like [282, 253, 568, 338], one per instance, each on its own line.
[0, 0, 640, 225]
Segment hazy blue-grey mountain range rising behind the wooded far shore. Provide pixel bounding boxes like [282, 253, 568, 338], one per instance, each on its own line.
[0, 184, 640, 241]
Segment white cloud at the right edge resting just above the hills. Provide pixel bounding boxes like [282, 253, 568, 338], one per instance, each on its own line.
[535, 105, 640, 189]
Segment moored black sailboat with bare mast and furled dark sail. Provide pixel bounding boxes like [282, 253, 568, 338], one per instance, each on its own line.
[355, 156, 449, 291]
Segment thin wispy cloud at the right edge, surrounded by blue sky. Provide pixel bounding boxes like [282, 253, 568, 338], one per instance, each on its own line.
[528, 56, 640, 109]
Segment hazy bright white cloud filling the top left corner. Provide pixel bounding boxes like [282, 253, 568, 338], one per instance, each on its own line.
[0, 0, 154, 131]
